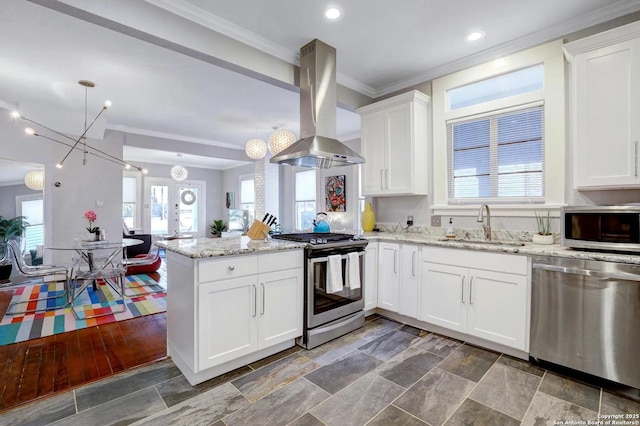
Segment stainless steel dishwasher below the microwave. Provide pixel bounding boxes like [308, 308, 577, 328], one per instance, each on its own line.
[530, 256, 640, 388]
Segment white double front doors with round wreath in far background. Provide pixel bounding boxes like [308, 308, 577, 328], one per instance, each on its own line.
[144, 178, 206, 237]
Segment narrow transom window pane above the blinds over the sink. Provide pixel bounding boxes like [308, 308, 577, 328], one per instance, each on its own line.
[447, 64, 544, 110]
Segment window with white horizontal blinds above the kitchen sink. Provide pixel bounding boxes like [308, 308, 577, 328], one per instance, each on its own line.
[447, 103, 544, 204]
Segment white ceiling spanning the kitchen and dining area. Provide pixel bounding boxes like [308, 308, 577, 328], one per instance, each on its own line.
[0, 0, 640, 176]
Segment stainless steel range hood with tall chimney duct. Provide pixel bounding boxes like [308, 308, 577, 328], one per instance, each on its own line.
[270, 39, 364, 169]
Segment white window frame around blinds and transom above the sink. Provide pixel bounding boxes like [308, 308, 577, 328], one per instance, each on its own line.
[431, 40, 566, 217]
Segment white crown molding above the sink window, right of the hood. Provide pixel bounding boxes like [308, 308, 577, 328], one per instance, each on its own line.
[375, 0, 640, 97]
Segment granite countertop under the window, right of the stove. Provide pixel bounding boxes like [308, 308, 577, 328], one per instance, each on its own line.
[363, 232, 640, 265]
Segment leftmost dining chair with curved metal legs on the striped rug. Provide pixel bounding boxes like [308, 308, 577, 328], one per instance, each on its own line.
[5, 239, 70, 315]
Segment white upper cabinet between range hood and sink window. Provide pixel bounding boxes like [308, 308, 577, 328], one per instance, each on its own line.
[357, 90, 430, 196]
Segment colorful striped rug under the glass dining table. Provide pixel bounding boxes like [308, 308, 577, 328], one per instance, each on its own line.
[0, 274, 167, 346]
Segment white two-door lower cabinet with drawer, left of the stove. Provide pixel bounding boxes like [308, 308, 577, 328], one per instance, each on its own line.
[196, 251, 303, 371]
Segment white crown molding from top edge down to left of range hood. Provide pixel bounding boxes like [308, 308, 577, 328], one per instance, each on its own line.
[145, 0, 300, 65]
